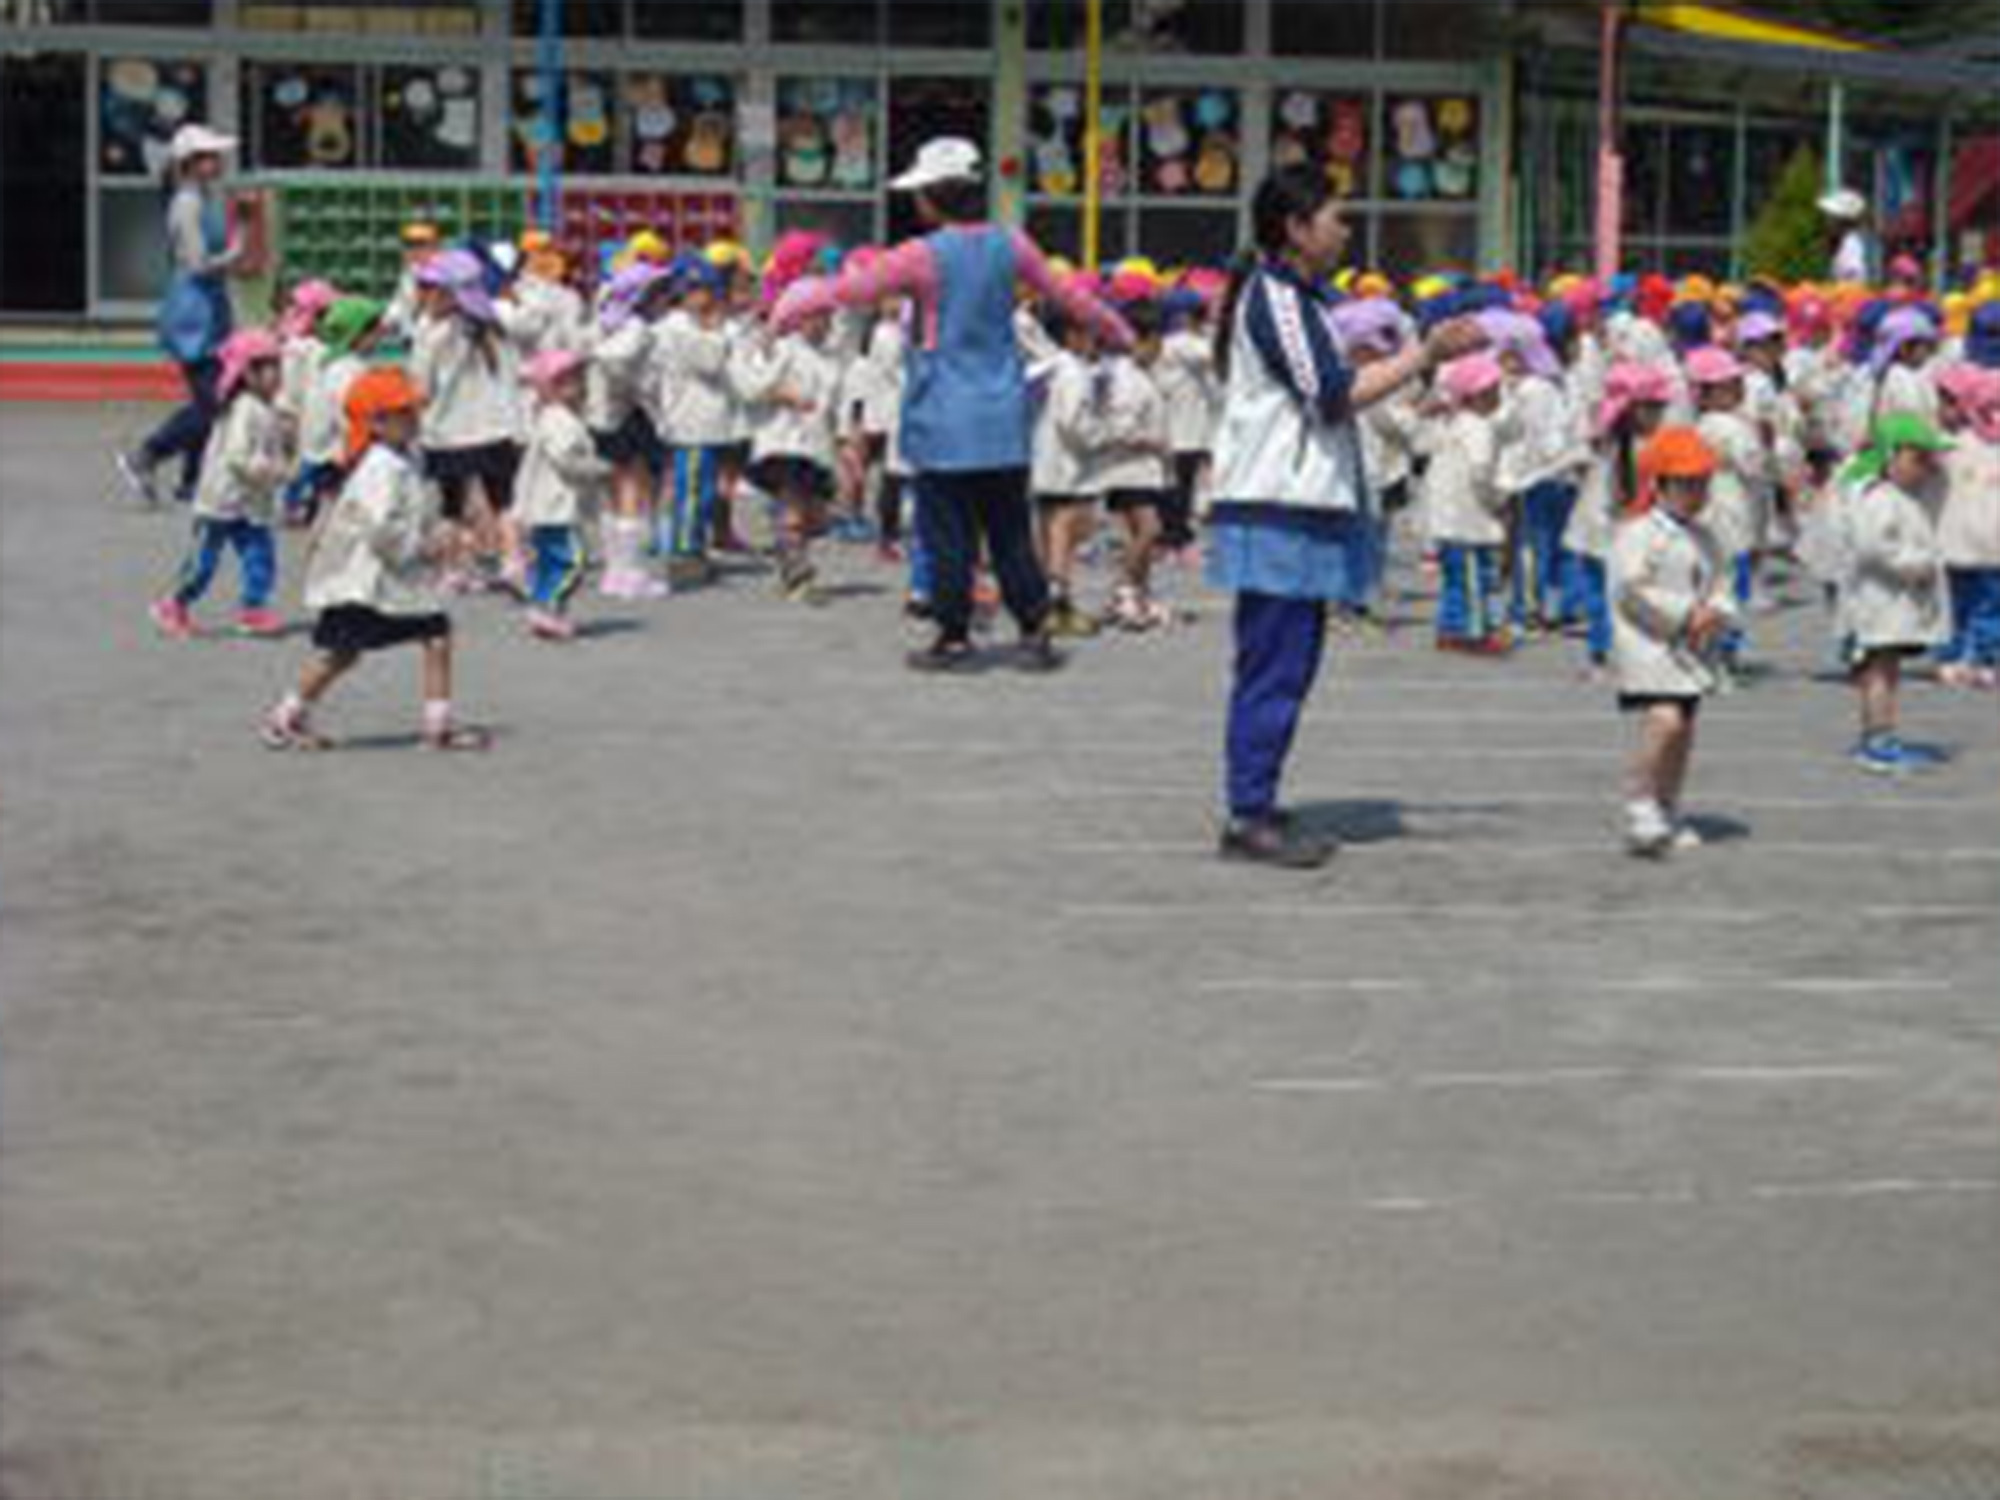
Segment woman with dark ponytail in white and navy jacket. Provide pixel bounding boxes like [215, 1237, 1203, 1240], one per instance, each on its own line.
[1208, 168, 1486, 870]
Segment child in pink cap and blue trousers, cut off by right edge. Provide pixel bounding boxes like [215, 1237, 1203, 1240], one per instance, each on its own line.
[1938, 364, 2000, 688]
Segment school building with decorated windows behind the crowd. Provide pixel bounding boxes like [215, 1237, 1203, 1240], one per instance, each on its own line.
[0, 0, 2000, 322]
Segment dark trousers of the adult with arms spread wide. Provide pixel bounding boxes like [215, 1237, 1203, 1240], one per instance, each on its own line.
[916, 468, 1048, 642]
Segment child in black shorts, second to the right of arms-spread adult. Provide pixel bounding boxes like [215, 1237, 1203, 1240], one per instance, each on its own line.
[1092, 302, 1172, 632]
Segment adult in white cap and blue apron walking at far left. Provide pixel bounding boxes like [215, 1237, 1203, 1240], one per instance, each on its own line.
[118, 124, 244, 504]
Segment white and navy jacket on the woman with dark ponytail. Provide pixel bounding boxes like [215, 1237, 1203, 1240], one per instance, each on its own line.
[1214, 260, 1370, 512]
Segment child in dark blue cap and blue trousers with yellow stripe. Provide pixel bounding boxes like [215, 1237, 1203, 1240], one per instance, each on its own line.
[656, 254, 740, 586]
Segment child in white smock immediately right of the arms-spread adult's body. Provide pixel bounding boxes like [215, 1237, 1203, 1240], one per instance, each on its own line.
[1030, 308, 1100, 640]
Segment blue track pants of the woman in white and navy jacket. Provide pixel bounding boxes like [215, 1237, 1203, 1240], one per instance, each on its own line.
[1224, 594, 1326, 820]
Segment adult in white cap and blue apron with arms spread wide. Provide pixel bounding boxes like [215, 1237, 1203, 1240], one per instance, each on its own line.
[774, 136, 1132, 672]
